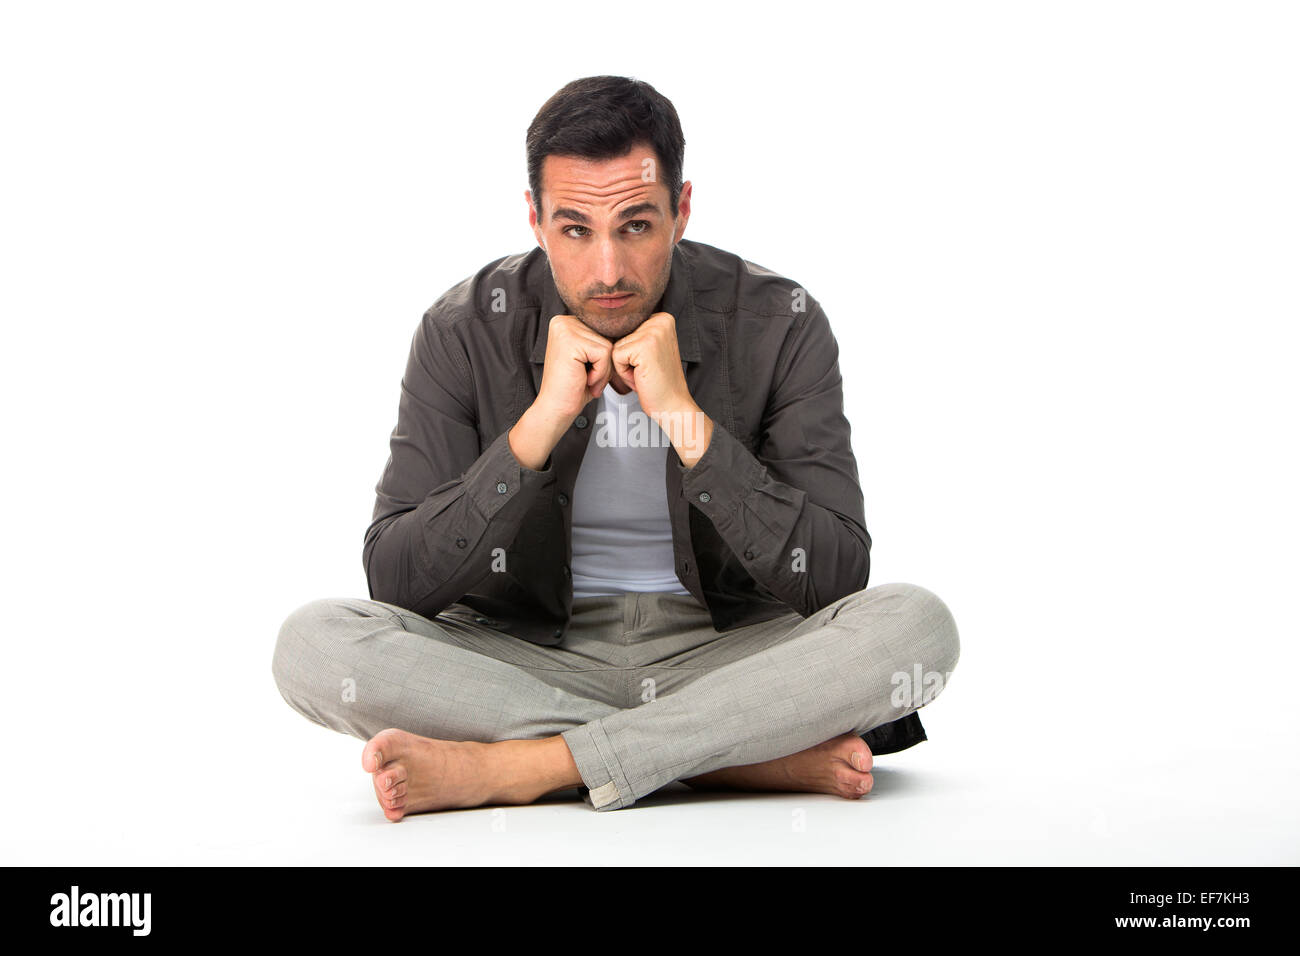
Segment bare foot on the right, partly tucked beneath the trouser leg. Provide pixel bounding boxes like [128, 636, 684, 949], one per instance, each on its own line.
[681, 734, 872, 800]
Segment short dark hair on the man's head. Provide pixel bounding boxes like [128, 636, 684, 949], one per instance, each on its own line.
[527, 77, 686, 222]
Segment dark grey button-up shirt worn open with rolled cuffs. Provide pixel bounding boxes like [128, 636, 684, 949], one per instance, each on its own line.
[363, 239, 924, 753]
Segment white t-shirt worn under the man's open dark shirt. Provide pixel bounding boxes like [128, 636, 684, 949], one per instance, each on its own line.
[571, 385, 690, 597]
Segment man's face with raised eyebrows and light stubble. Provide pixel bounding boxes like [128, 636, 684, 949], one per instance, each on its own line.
[524, 146, 690, 342]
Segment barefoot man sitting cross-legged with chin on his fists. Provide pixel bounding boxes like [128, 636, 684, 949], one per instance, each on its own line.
[273, 77, 958, 821]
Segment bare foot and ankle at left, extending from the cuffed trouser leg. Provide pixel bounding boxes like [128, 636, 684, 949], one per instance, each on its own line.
[361, 728, 582, 822]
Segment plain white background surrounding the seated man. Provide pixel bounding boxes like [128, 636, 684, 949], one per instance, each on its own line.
[0, 3, 1300, 865]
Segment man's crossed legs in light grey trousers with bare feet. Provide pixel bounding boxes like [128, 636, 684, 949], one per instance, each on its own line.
[273, 584, 959, 819]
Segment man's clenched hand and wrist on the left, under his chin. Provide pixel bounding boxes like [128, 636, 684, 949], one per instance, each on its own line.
[510, 315, 614, 471]
